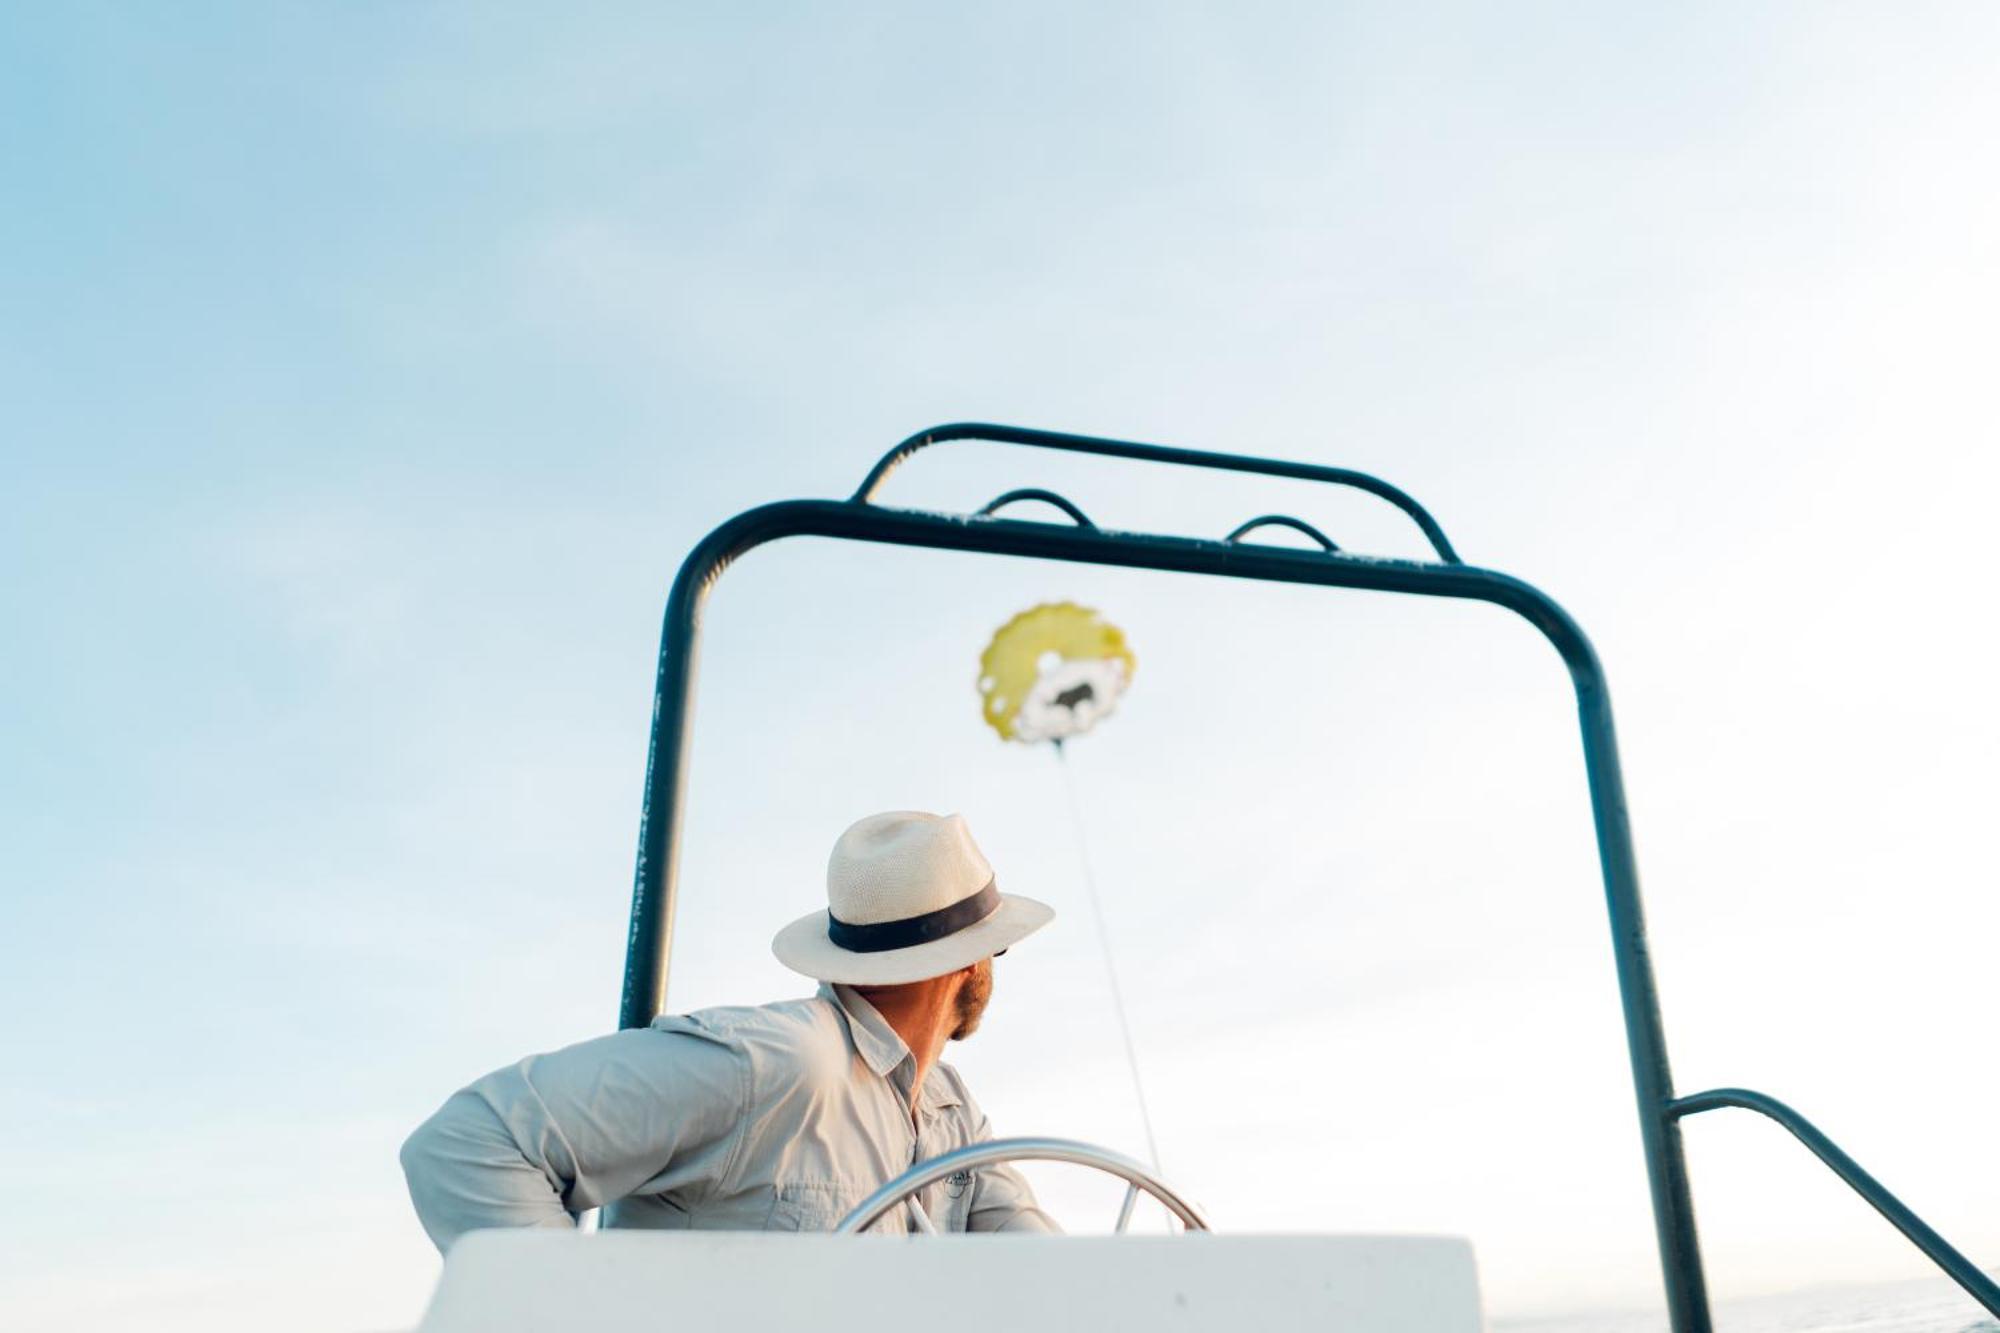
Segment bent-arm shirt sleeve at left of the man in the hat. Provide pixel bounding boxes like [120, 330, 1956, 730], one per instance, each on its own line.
[402, 1019, 748, 1251]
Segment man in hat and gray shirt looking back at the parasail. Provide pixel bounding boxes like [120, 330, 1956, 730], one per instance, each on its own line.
[402, 811, 1056, 1251]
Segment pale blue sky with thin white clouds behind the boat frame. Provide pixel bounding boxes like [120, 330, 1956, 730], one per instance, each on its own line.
[0, 4, 2000, 1331]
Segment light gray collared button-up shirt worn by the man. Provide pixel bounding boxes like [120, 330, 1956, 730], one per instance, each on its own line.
[402, 985, 1058, 1251]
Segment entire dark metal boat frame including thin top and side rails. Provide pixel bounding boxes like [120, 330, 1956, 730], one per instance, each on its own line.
[618, 424, 2000, 1333]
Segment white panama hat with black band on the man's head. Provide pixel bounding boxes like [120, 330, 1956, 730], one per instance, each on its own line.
[770, 811, 1056, 987]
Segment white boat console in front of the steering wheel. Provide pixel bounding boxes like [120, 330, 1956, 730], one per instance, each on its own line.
[420, 1231, 1484, 1333]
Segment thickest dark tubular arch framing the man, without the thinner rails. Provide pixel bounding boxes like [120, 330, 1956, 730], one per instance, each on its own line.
[618, 492, 1714, 1333]
